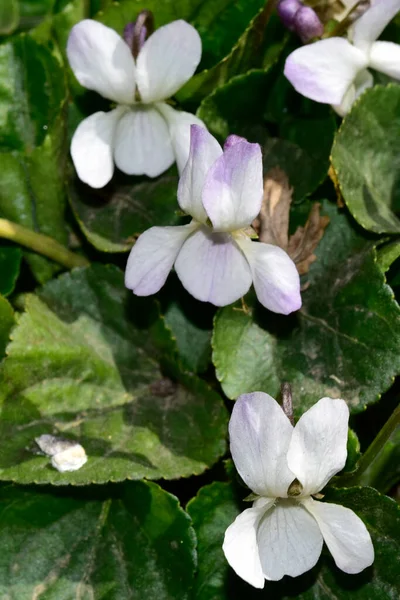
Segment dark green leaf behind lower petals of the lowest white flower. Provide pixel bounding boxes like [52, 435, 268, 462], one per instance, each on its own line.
[188, 483, 400, 600]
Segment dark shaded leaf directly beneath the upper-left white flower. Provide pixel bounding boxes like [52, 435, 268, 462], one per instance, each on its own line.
[69, 174, 181, 252]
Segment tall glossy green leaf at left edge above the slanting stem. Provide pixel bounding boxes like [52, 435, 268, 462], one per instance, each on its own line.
[0, 35, 67, 282]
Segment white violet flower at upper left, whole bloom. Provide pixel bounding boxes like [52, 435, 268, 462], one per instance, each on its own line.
[67, 19, 202, 188]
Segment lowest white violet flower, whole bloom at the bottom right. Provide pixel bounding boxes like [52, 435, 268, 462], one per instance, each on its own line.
[223, 392, 374, 588]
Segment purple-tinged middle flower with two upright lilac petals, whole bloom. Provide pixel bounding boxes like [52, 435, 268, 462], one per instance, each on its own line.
[125, 125, 301, 314]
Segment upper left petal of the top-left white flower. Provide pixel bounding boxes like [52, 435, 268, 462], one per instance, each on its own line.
[67, 19, 135, 104]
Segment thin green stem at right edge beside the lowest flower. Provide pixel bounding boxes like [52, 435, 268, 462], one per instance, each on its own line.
[335, 405, 400, 487]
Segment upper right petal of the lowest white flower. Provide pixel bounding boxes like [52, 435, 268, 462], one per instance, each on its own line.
[287, 398, 349, 495]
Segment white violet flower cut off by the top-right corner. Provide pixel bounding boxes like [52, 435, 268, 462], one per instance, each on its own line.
[284, 0, 400, 116]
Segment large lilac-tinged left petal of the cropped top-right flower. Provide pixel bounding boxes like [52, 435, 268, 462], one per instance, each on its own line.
[284, 38, 368, 104]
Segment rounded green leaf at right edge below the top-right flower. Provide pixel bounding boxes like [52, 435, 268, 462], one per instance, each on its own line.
[332, 85, 400, 233]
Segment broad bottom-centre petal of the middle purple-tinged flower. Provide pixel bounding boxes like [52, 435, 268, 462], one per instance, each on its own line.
[175, 226, 251, 306]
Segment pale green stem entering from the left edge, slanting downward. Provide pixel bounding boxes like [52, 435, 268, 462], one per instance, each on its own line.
[0, 219, 90, 269]
